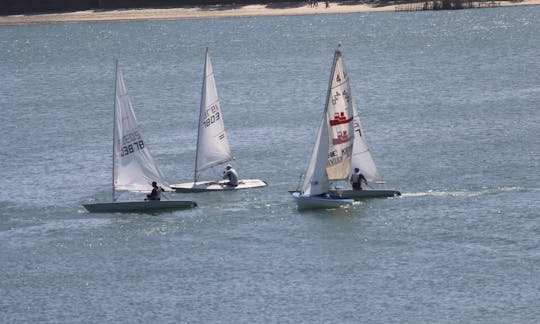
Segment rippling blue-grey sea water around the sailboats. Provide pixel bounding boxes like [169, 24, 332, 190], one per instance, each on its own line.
[0, 6, 540, 323]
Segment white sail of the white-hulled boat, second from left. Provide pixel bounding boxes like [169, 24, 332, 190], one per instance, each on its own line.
[195, 49, 233, 181]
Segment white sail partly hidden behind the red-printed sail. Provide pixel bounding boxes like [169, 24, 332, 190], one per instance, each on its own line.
[351, 100, 383, 182]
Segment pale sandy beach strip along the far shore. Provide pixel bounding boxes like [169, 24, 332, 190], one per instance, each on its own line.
[0, 0, 540, 25]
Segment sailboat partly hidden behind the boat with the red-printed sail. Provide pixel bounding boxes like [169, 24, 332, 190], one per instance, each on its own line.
[330, 99, 401, 200]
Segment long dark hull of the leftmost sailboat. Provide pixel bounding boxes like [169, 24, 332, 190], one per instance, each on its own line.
[83, 200, 197, 213]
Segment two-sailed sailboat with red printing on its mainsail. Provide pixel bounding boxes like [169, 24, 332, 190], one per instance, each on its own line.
[292, 46, 354, 209]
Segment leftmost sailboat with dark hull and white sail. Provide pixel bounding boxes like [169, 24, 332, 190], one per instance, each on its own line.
[83, 61, 197, 213]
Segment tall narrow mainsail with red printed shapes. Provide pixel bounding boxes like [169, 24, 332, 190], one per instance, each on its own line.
[326, 49, 354, 180]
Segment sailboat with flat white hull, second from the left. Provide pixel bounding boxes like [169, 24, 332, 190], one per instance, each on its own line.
[170, 48, 267, 193]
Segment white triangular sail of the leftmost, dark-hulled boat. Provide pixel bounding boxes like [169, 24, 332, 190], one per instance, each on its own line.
[113, 62, 168, 195]
